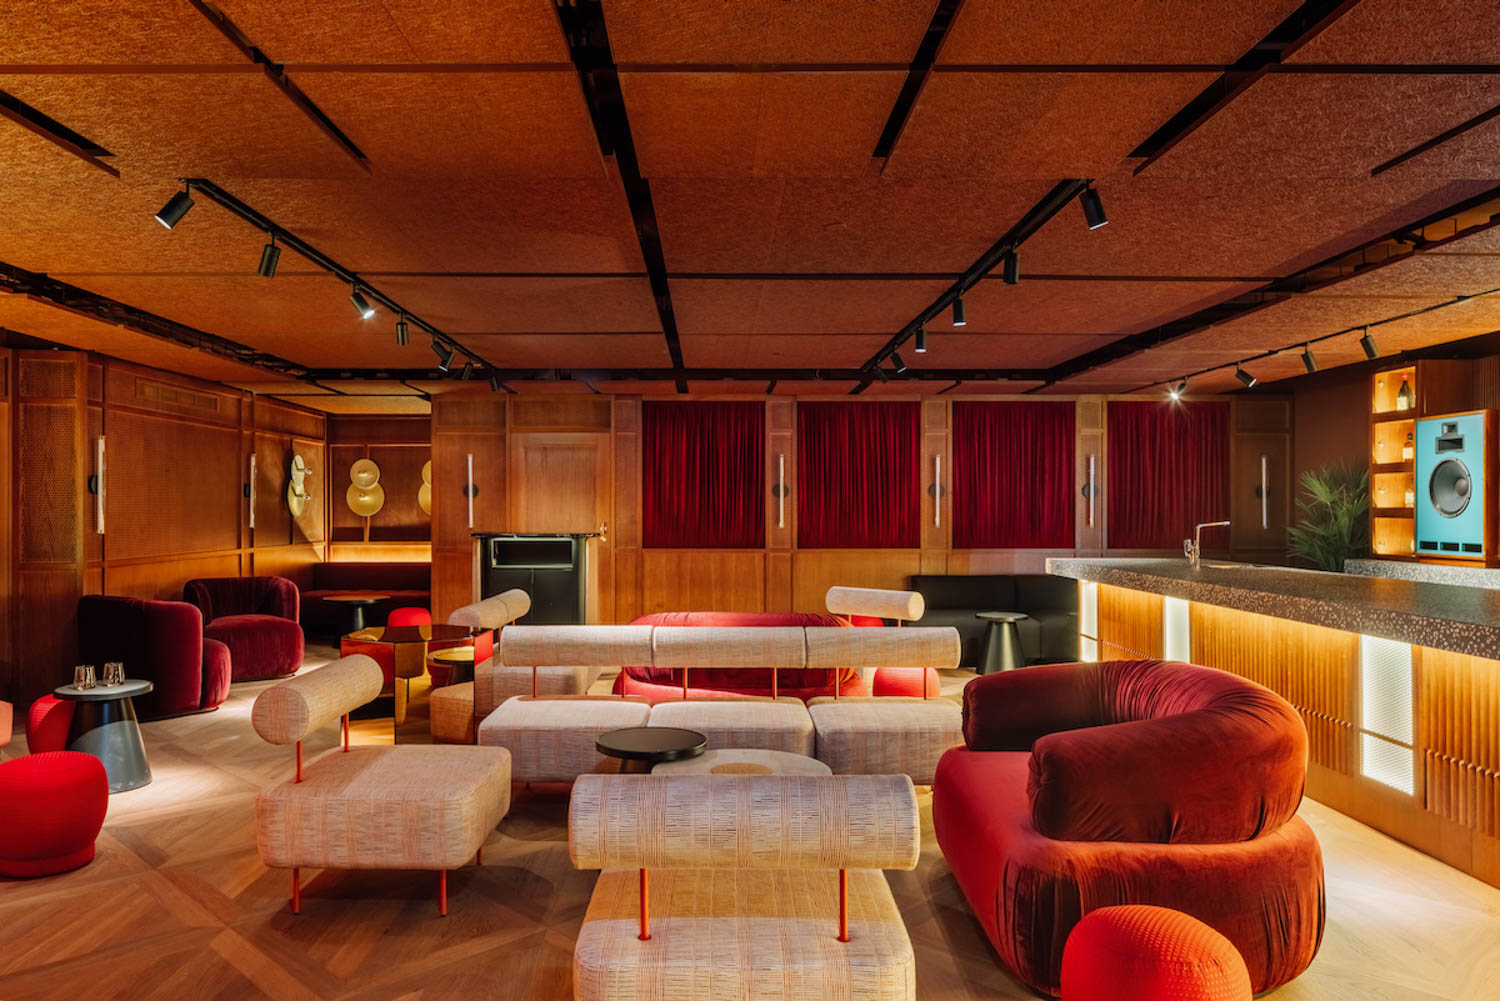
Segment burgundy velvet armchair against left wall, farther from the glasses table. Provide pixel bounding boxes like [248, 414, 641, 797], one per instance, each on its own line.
[183, 576, 303, 681]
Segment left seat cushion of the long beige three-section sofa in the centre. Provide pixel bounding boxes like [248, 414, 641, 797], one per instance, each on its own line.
[479, 695, 651, 782]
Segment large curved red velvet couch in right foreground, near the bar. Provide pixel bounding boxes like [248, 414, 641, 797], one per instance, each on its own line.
[933, 660, 1325, 995]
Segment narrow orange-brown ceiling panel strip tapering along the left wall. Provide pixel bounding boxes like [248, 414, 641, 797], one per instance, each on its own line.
[0, 294, 279, 381]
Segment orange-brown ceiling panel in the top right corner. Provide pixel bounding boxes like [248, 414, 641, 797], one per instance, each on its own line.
[1289, 0, 1500, 63]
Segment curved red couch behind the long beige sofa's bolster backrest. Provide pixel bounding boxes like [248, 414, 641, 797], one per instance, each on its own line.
[615, 612, 881, 702]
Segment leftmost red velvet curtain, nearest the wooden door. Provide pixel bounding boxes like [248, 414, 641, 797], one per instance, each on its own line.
[641, 401, 765, 549]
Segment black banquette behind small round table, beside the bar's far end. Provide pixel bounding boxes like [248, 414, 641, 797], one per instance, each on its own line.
[911, 573, 1079, 668]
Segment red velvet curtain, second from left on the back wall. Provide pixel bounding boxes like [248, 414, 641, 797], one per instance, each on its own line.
[797, 401, 921, 549]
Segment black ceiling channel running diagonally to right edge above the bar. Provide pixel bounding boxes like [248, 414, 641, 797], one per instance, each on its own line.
[1031, 186, 1500, 392]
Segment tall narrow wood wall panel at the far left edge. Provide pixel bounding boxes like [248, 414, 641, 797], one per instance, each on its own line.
[15, 405, 83, 563]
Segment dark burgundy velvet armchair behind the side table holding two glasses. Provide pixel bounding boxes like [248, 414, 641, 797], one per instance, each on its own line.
[78, 594, 231, 719]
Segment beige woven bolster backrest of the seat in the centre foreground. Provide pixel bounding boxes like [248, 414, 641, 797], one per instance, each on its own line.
[569, 774, 921, 869]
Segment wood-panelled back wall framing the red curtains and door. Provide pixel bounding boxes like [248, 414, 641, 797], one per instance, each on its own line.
[432, 390, 1266, 627]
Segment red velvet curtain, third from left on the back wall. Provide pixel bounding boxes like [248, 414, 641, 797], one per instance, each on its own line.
[953, 401, 1076, 549]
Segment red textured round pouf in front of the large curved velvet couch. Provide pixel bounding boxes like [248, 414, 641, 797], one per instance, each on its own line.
[1062, 905, 1251, 1001]
